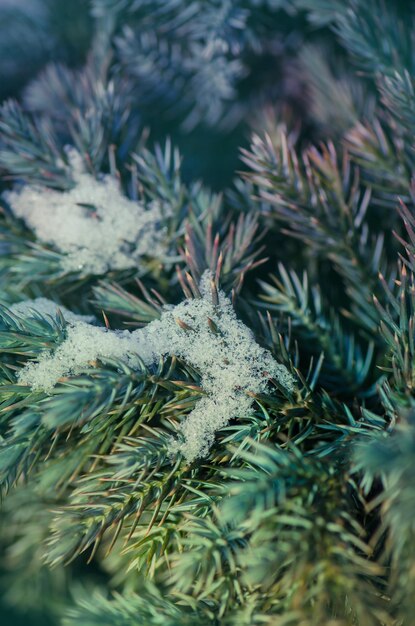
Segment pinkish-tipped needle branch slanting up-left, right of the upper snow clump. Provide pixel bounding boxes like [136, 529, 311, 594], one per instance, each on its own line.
[244, 131, 389, 332]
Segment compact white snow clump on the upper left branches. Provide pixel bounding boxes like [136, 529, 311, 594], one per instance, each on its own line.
[5, 148, 166, 274]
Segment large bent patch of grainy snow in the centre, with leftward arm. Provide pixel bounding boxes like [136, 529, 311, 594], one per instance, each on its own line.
[19, 273, 294, 461]
